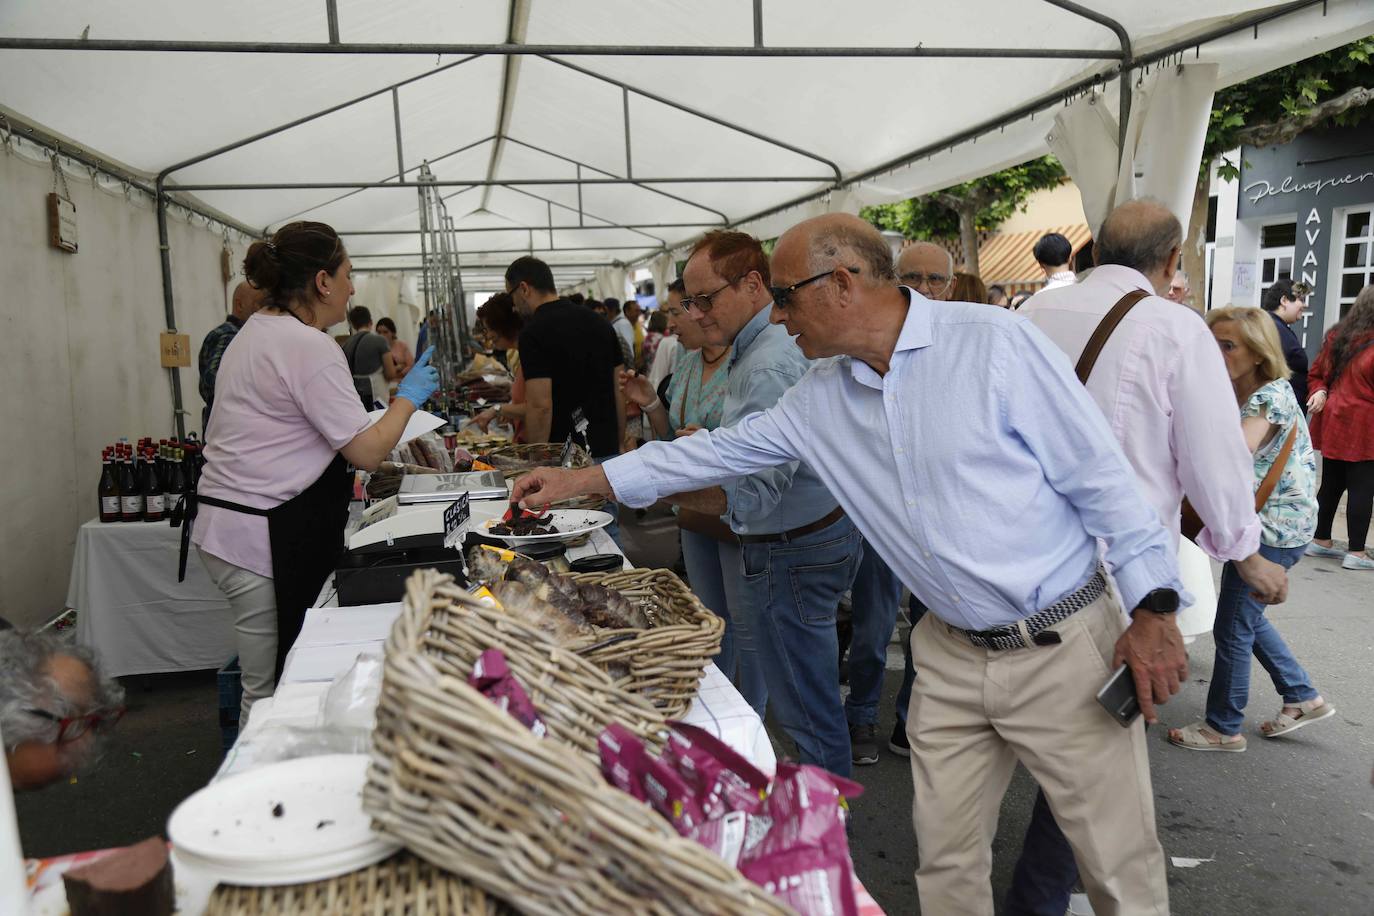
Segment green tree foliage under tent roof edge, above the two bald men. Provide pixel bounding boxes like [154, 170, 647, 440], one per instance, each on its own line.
[859, 155, 1065, 239]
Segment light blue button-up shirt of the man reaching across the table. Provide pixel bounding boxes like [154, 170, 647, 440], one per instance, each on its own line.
[603, 290, 1181, 630]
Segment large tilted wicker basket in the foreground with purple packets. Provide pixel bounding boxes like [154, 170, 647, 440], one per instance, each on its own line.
[363, 570, 791, 916]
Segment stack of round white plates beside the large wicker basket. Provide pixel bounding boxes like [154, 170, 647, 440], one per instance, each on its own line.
[168, 754, 400, 887]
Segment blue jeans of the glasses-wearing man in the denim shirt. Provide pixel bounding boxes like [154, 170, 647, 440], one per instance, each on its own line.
[739, 518, 863, 776]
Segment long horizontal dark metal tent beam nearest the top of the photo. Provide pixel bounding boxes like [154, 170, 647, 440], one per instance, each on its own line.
[0, 37, 1121, 60]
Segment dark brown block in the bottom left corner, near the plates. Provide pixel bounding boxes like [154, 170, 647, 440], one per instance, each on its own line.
[62, 836, 176, 916]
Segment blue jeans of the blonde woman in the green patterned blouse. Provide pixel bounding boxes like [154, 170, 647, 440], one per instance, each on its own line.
[1206, 544, 1318, 735]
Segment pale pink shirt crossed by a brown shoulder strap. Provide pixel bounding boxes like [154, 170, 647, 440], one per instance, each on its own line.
[1020, 264, 1260, 560]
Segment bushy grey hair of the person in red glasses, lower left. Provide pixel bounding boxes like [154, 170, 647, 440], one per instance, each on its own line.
[0, 630, 124, 750]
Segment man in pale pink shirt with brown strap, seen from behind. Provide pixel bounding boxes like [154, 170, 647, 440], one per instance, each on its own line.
[1006, 201, 1287, 916]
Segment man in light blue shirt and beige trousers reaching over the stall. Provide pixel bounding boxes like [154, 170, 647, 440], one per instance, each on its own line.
[514, 214, 1187, 916]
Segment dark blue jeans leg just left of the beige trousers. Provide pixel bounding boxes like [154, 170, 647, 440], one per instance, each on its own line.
[845, 544, 901, 725]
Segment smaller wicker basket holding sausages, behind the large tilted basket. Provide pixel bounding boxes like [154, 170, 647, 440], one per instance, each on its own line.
[569, 570, 725, 718]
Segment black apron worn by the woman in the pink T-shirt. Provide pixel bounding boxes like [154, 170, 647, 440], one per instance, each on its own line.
[172, 455, 353, 680]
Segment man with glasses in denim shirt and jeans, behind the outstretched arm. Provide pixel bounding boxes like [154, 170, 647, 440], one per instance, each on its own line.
[672, 231, 861, 776]
